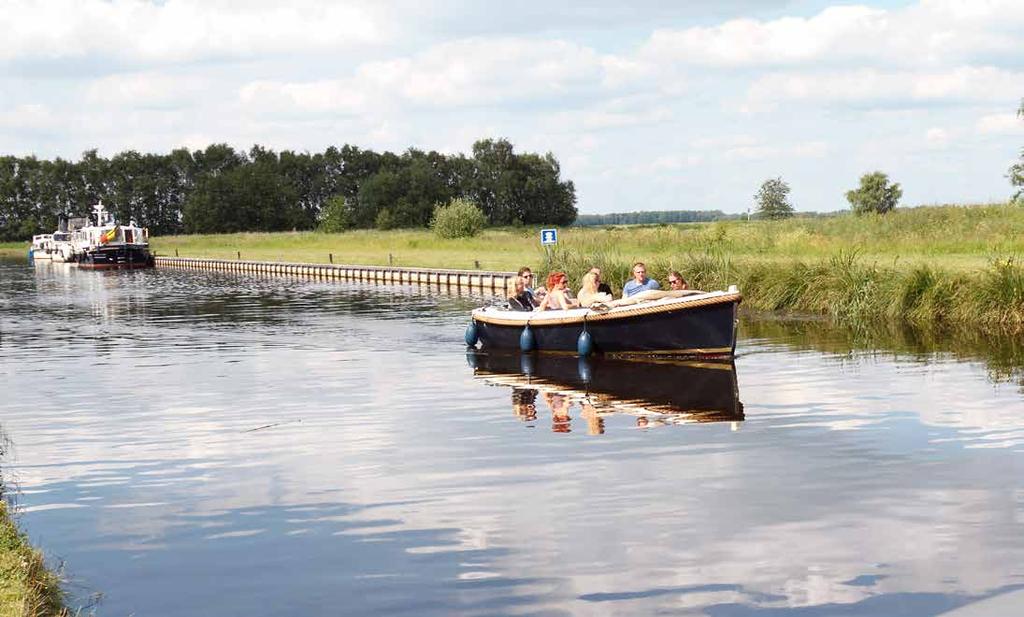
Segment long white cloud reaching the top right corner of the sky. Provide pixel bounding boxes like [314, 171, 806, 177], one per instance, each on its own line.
[642, 0, 1024, 67]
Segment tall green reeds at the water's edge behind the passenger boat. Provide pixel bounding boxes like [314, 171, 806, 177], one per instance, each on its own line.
[553, 250, 1024, 333]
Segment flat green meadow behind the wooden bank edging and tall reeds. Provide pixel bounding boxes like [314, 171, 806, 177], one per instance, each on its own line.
[144, 205, 1024, 270]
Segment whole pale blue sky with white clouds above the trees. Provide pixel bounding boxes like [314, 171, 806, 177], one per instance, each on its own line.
[0, 0, 1024, 214]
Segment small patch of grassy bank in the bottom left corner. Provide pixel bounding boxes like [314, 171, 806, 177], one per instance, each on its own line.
[0, 499, 68, 617]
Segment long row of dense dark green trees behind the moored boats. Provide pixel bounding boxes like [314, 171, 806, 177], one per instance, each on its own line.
[0, 139, 577, 240]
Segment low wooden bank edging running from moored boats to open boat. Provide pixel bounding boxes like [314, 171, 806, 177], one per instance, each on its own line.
[156, 256, 515, 294]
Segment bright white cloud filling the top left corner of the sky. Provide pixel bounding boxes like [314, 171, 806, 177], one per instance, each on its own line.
[0, 0, 387, 63]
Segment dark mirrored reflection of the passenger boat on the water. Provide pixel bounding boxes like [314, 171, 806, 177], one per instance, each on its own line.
[466, 351, 743, 435]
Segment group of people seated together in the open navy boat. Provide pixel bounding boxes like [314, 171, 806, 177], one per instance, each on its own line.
[508, 262, 689, 311]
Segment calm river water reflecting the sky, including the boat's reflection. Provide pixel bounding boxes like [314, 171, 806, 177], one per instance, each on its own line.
[0, 262, 1024, 616]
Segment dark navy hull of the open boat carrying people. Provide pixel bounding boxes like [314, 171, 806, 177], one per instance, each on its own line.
[474, 294, 740, 357]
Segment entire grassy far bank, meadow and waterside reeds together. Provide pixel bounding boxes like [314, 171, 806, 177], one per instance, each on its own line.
[6, 204, 1024, 333]
